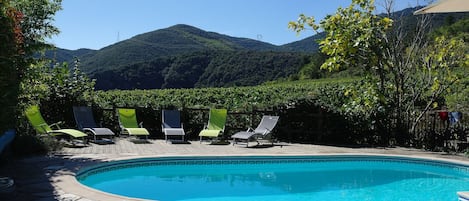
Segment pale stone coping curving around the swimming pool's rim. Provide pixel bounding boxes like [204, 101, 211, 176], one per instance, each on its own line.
[60, 153, 469, 201]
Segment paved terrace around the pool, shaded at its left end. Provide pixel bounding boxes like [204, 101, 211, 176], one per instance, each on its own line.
[0, 138, 469, 201]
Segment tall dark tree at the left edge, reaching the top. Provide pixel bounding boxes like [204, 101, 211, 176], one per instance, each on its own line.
[0, 0, 61, 133]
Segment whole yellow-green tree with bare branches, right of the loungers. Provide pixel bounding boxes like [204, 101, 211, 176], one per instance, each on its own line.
[289, 0, 467, 144]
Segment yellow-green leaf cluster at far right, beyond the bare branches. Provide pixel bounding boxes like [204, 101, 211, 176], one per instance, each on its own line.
[400, 25, 469, 131]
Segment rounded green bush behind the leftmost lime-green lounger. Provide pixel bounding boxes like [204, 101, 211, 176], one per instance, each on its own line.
[14, 60, 95, 154]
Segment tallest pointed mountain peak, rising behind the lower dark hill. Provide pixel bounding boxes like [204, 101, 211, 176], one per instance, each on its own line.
[66, 24, 288, 73]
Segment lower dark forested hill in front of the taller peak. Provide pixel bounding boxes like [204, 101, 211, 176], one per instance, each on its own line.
[93, 51, 309, 90]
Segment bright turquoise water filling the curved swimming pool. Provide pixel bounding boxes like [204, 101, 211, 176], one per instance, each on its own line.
[77, 156, 469, 201]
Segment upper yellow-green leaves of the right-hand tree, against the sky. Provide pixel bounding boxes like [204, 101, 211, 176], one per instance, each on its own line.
[290, 0, 392, 71]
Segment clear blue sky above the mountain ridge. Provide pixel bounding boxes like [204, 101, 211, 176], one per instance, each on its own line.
[49, 0, 417, 50]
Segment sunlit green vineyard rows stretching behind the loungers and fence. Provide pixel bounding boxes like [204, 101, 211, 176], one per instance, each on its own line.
[92, 79, 354, 112]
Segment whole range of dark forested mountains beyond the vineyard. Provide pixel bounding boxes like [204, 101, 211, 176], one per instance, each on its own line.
[47, 8, 469, 90]
